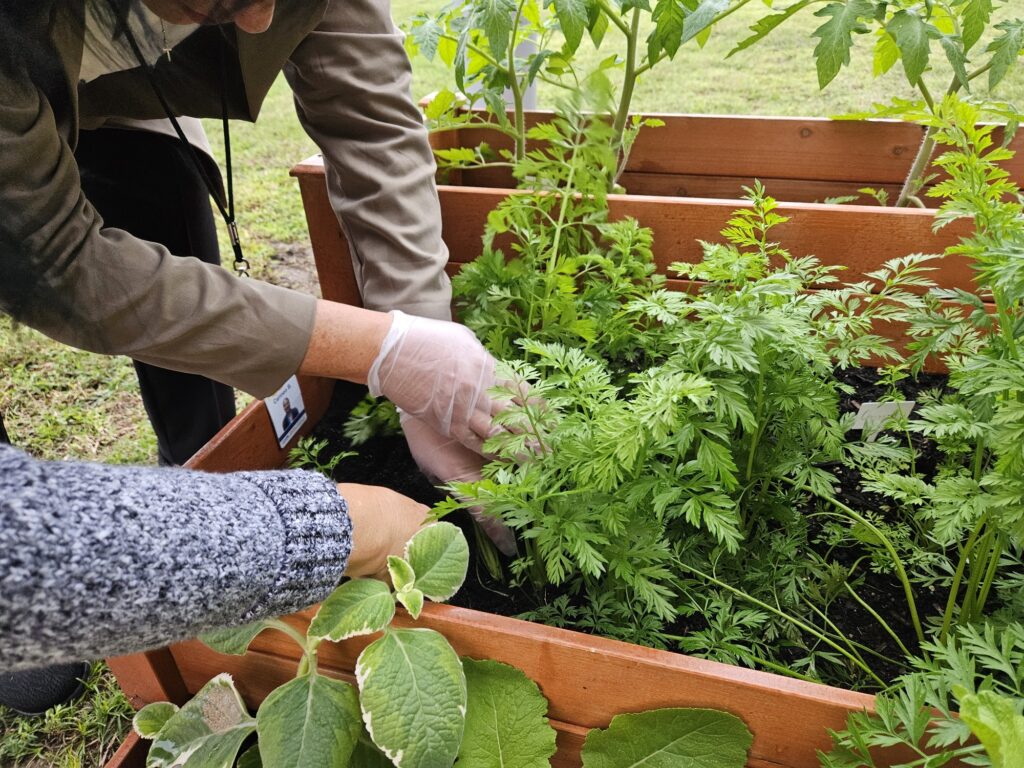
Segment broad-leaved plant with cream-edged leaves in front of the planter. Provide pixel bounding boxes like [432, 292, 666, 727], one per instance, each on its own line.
[134, 523, 752, 768]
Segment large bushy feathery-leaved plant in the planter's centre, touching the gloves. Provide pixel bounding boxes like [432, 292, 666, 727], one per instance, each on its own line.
[447, 176, 927, 674]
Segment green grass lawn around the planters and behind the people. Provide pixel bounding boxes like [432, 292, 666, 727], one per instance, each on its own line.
[0, 0, 1024, 768]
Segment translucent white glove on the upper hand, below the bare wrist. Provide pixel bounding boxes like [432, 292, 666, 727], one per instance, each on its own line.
[368, 310, 498, 454]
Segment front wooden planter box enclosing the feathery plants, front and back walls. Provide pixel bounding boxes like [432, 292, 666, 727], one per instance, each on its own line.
[108, 129, 991, 768]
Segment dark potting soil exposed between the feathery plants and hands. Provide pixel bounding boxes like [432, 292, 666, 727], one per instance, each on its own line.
[312, 369, 966, 692]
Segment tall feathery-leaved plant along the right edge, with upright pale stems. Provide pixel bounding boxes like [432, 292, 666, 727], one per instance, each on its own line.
[823, 97, 1024, 641]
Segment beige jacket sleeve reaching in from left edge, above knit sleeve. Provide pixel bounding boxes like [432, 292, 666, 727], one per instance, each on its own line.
[0, 69, 315, 396]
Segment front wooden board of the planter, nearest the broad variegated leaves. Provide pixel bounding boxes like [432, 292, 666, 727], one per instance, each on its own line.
[106, 372, 873, 768]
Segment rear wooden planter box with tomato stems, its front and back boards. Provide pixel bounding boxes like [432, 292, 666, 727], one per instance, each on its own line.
[293, 112, 1024, 371]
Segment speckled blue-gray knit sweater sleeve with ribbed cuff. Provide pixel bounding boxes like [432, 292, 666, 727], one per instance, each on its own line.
[0, 445, 351, 672]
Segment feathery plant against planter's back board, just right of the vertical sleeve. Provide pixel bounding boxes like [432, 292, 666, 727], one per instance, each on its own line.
[453, 102, 665, 359]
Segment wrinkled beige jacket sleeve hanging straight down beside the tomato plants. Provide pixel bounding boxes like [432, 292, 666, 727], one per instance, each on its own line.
[285, 0, 452, 319]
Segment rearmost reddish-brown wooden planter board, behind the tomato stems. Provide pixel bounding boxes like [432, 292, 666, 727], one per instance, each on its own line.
[430, 110, 1024, 207]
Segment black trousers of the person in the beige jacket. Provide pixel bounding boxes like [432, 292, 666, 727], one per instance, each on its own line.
[75, 128, 234, 464]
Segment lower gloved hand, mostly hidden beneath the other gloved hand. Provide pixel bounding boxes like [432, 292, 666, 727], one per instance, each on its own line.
[401, 412, 515, 557]
